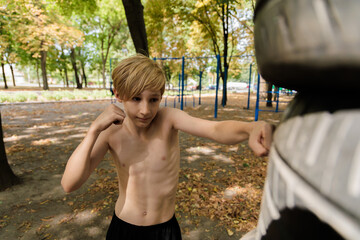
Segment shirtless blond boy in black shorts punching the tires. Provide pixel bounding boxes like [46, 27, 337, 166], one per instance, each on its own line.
[61, 55, 272, 240]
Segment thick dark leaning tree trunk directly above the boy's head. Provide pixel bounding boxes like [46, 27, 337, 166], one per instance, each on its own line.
[122, 0, 149, 56]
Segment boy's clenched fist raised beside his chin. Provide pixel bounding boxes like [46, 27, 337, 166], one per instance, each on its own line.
[90, 104, 126, 132]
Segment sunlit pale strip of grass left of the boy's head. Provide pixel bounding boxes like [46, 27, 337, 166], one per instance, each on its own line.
[0, 90, 111, 103]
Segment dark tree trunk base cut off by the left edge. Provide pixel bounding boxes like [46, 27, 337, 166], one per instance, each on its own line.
[0, 112, 20, 191]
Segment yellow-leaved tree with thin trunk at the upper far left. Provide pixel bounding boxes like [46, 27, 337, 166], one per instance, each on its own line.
[7, 0, 83, 90]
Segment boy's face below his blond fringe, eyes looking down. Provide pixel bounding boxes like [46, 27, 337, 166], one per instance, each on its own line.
[122, 90, 161, 128]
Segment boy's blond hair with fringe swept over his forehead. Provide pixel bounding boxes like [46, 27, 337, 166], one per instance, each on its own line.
[111, 54, 166, 100]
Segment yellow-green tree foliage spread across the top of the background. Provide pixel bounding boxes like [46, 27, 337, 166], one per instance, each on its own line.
[0, 0, 255, 92]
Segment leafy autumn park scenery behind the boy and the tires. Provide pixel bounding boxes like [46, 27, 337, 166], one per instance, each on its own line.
[0, 0, 286, 240]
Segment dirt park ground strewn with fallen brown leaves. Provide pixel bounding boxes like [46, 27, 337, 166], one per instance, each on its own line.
[0, 94, 290, 240]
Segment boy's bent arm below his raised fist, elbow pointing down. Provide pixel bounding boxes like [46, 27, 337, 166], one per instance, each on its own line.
[61, 128, 108, 192]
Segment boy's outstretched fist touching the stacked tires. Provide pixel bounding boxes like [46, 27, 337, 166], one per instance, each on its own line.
[249, 121, 275, 156]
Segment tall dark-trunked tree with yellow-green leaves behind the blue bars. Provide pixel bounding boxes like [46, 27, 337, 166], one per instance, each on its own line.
[177, 0, 251, 106]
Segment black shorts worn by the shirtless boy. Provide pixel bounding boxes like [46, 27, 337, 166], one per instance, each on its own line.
[106, 213, 181, 240]
